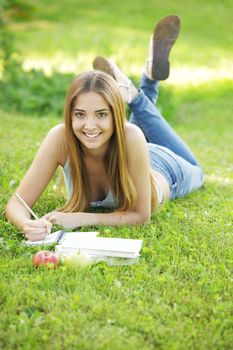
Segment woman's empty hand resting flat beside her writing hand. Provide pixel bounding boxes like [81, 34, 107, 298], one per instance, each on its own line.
[43, 211, 82, 229]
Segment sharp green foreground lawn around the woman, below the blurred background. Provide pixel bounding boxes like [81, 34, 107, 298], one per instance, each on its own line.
[0, 89, 233, 349]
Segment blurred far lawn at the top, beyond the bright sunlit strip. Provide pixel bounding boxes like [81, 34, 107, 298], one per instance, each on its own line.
[10, 0, 233, 72]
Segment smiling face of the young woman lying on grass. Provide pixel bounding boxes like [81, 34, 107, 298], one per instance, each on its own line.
[72, 91, 114, 155]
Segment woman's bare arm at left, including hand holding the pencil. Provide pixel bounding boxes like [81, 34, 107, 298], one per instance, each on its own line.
[6, 124, 65, 240]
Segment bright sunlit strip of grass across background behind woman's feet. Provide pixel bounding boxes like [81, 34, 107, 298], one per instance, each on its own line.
[23, 52, 233, 86]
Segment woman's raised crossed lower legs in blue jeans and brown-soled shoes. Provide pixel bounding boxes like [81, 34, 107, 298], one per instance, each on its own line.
[93, 15, 202, 165]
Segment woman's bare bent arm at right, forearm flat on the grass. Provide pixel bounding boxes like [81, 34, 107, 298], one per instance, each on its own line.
[45, 124, 151, 228]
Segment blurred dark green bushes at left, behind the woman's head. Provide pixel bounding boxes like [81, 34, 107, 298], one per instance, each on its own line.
[0, 0, 72, 116]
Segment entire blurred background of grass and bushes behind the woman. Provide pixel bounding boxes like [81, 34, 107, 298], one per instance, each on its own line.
[0, 0, 233, 118]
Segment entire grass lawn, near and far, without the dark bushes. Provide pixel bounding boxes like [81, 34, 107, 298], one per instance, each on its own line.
[0, 0, 233, 350]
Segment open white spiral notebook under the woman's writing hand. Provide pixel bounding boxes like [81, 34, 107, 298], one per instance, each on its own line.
[25, 231, 99, 246]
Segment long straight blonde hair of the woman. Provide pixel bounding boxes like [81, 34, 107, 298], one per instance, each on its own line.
[61, 71, 155, 212]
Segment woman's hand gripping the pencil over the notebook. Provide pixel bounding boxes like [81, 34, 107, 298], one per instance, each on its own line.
[22, 219, 53, 242]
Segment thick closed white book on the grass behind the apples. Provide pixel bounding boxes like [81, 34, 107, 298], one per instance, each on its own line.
[58, 237, 142, 258]
